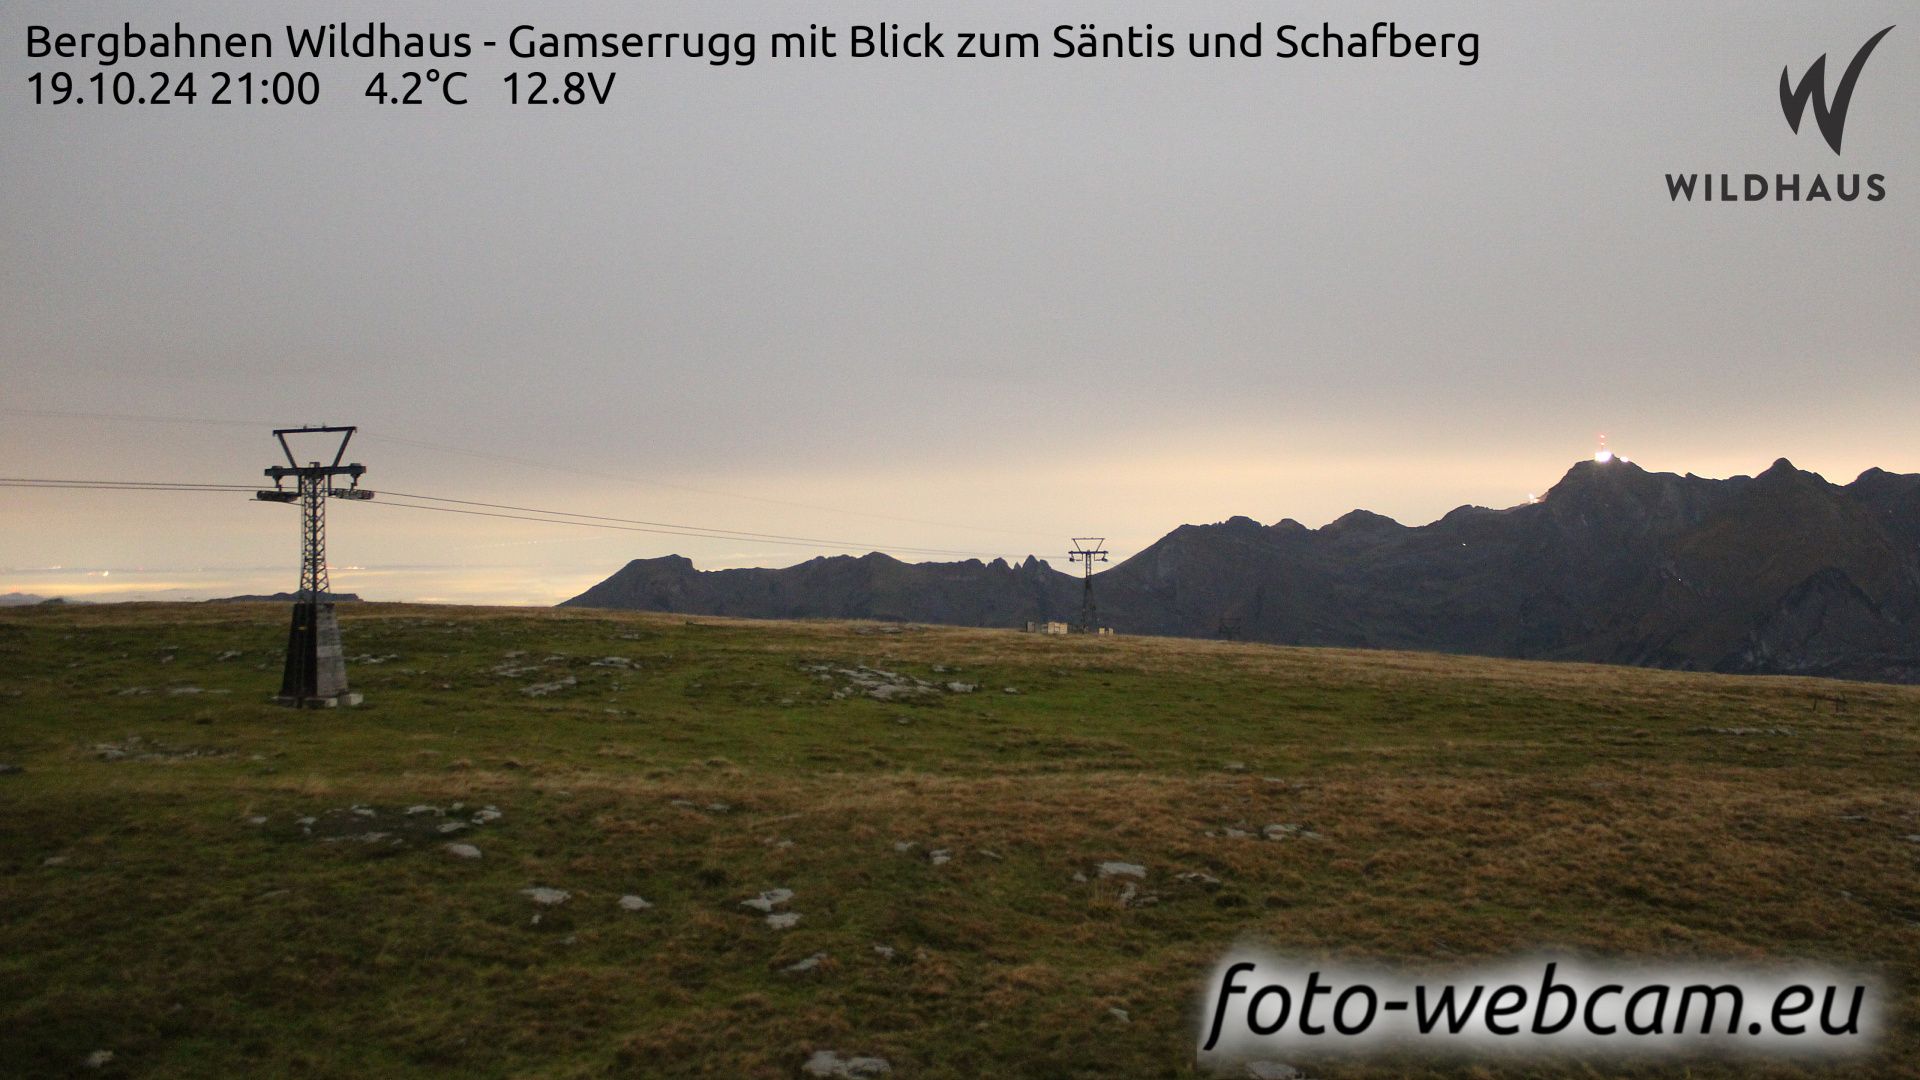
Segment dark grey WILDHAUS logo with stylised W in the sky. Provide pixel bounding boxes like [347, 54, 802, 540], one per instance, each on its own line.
[1667, 27, 1893, 202]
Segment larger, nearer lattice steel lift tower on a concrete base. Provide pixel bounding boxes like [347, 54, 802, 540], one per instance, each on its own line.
[253, 427, 372, 709]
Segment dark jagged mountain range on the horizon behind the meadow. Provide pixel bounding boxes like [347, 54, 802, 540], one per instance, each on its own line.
[566, 459, 1920, 682]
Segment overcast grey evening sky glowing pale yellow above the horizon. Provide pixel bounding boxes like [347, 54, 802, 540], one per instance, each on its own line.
[0, 0, 1920, 603]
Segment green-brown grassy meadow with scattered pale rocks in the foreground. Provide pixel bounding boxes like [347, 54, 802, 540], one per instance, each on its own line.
[0, 605, 1920, 1076]
